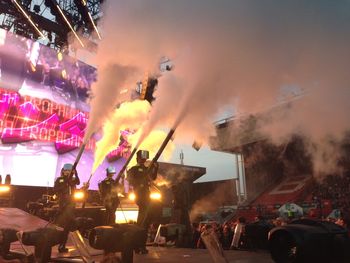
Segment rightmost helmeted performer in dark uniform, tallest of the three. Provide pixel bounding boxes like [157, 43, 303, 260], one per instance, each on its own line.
[127, 150, 158, 254]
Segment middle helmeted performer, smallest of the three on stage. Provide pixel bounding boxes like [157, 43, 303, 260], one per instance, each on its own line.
[98, 166, 120, 225]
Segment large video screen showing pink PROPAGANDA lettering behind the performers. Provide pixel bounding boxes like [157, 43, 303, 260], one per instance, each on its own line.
[0, 29, 129, 189]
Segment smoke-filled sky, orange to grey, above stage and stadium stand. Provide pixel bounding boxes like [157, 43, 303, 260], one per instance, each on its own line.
[69, 0, 350, 182]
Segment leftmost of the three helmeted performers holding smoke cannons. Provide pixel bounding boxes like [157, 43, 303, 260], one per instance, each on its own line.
[54, 163, 80, 253]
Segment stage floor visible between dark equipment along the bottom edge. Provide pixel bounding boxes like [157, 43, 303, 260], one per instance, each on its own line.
[0, 208, 273, 263]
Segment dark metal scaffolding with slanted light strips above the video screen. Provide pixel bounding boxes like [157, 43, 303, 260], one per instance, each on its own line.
[0, 0, 103, 51]
